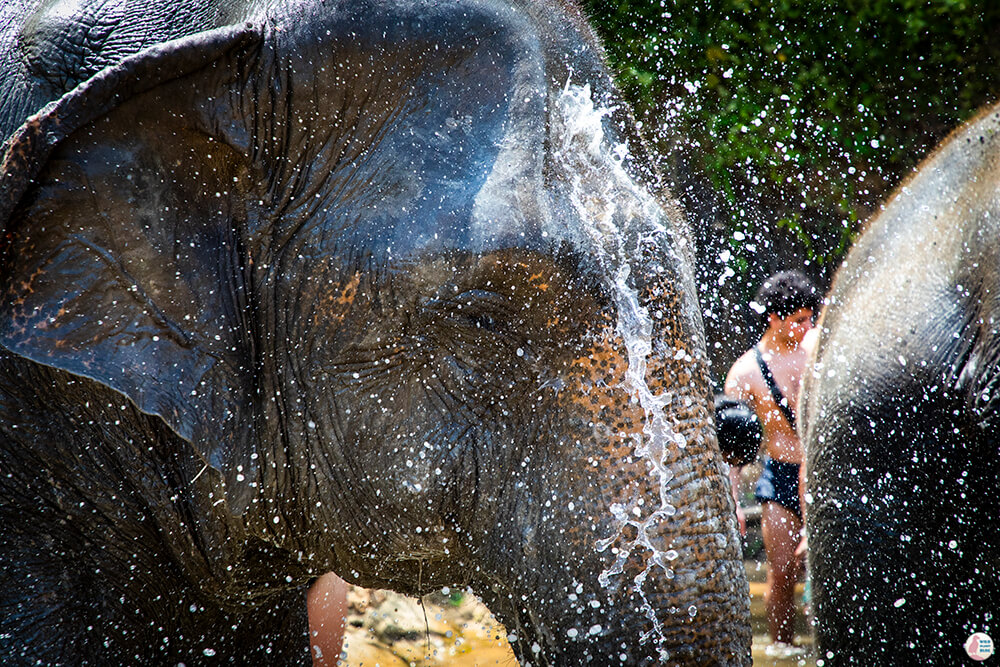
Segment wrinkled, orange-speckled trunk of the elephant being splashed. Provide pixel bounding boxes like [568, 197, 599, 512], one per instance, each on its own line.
[476, 270, 750, 665]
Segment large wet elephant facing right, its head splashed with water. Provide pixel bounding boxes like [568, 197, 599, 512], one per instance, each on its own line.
[0, 0, 750, 665]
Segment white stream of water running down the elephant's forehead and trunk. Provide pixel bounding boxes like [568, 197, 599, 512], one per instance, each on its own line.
[553, 82, 686, 654]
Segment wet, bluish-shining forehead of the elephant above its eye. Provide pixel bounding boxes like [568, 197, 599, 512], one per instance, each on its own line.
[234, 3, 674, 278]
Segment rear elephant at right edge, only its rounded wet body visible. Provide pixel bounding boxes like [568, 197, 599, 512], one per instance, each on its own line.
[802, 106, 1000, 666]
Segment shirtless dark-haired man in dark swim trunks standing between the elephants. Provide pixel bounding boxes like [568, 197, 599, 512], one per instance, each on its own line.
[725, 271, 820, 656]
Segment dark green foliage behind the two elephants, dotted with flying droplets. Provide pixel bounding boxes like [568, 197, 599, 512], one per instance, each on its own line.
[585, 0, 1000, 381]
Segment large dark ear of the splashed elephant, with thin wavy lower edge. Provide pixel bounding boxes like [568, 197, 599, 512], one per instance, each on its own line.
[0, 26, 259, 511]
